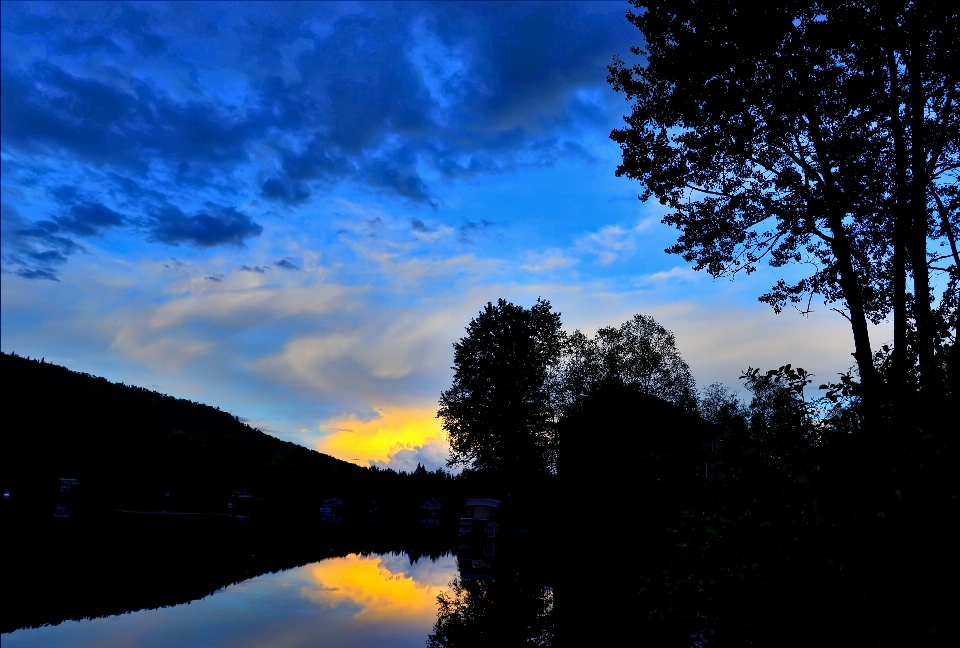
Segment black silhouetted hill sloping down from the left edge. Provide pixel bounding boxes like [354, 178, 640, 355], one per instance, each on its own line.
[0, 354, 372, 516]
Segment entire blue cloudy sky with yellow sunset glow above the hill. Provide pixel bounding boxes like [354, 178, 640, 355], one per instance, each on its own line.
[0, 2, 892, 470]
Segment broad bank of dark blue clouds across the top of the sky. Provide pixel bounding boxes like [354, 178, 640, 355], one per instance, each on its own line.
[0, 3, 637, 278]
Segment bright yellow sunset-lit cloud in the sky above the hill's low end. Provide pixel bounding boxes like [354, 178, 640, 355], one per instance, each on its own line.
[317, 407, 447, 466]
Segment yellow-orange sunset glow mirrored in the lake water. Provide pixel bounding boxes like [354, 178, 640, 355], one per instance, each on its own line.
[301, 554, 452, 623]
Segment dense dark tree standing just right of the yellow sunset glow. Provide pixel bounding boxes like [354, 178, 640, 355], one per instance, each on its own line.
[437, 299, 564, 476]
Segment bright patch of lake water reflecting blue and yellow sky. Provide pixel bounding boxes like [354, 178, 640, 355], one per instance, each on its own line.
[3, 554, 457, 648]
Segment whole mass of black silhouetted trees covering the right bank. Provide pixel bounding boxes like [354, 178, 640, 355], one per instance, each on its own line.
[433, 0, 960, 645]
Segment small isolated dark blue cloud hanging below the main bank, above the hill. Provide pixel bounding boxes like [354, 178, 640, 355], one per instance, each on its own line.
[148, 206, 263, 247]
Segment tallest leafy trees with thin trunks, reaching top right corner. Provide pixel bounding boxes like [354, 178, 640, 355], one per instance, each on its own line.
[609, 0, 960, 398]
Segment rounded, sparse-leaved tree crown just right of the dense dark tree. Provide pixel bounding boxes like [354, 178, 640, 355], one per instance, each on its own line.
[554, 314, 697, 411]
